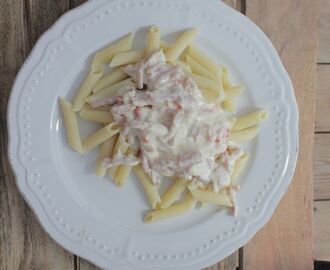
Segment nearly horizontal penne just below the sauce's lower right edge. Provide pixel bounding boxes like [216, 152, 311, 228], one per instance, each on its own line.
[188, 187, 233, 207]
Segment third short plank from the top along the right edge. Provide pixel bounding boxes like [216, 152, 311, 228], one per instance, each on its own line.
[314, 133, 330, 200]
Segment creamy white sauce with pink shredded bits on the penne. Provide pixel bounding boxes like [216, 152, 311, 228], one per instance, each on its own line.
[105, 51, 242, 191]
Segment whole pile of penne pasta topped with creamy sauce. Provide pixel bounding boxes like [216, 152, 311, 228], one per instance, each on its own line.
[60, 26, 268, 223]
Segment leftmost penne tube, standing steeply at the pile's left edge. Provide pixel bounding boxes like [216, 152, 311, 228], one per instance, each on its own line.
[60, 98, 82, 153]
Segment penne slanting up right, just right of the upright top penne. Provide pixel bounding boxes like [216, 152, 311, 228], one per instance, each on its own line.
[165, 28, 200, 62]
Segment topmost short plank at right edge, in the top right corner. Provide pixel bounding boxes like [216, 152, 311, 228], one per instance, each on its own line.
[317, 0, 330, 63]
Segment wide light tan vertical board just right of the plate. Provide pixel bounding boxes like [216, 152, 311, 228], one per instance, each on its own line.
[243, 0, 318, 270]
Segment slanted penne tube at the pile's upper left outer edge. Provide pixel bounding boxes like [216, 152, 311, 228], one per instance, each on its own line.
[92, 33, 134, 69]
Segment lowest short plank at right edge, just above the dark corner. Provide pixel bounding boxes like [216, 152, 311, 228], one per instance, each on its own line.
[314, 201, 330, 262]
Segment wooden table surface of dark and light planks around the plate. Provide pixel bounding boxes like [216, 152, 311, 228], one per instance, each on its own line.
[0, 0, 324, 270]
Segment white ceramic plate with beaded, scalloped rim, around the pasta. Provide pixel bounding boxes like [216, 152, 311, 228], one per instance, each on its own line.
[8, 0, 298, 270]
